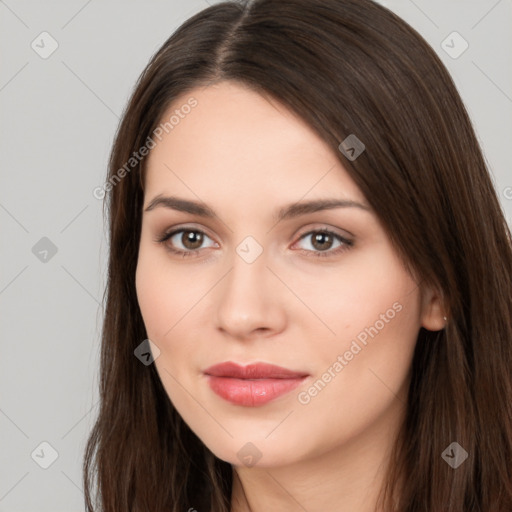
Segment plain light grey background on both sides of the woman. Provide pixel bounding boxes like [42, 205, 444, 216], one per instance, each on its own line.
[0, 0, 512, 512]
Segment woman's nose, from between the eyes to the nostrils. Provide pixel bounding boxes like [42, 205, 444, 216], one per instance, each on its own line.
[215, 246, 286, 340]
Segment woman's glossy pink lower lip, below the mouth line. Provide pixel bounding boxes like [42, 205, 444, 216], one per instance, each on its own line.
[207, 375, 306, 407]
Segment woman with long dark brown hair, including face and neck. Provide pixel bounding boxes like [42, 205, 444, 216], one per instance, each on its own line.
[84, 0, 512, 512]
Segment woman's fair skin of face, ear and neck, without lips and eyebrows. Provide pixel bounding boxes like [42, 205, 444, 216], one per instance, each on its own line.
[136, 82, 444, 512]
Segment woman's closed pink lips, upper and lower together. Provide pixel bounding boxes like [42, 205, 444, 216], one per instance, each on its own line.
[203, 361, 309, 407]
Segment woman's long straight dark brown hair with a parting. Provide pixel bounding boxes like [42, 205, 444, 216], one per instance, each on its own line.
[83, 0, 512, 512]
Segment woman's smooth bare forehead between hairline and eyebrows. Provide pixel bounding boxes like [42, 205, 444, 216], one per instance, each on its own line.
[145, 82, 364, 206]
